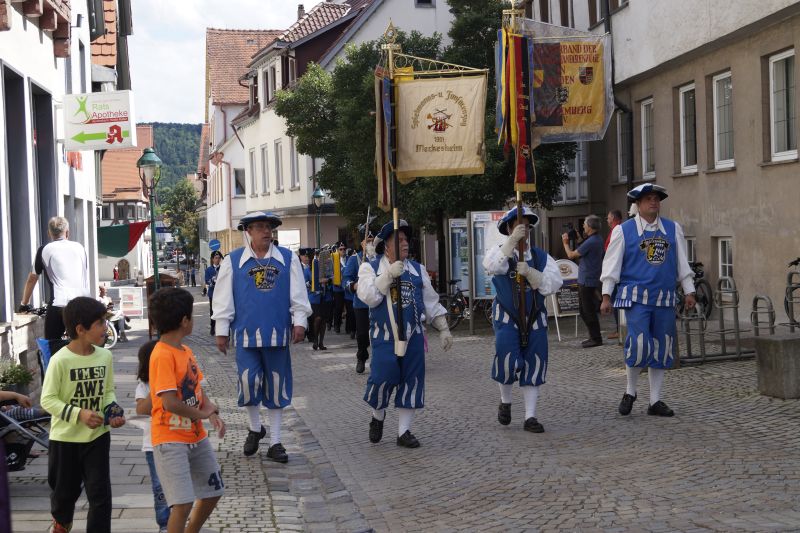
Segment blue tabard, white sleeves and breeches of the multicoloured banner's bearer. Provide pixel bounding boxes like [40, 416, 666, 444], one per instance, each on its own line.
[485, 247, 561, 386]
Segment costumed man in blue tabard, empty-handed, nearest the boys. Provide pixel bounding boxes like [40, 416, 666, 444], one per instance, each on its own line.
[213, 211, 311, 463]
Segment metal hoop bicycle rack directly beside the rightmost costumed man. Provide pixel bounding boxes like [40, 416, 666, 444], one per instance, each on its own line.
[680, 277, 752, 364]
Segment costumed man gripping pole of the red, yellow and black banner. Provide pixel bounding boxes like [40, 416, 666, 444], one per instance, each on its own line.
[483, 206, 563, 433]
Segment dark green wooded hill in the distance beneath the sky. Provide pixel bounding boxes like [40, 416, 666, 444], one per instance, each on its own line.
[145, 122, 202, 189]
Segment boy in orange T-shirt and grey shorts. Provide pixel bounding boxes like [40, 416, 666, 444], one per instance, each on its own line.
[148, 287, 225, 533]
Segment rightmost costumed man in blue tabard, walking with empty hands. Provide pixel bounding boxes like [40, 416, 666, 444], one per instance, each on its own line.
[600, 183, 695, 416]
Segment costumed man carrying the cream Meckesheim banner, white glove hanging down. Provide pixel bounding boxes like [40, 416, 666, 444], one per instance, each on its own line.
[358, 220, 453, 448]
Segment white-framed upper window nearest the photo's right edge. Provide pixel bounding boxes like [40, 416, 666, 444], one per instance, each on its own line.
[769, 49, 797, 161]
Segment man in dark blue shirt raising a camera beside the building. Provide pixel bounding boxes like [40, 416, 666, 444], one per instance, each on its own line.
[561, 215, 603, 348]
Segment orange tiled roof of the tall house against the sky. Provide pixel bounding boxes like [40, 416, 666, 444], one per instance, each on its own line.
[203, 28, 281, 107]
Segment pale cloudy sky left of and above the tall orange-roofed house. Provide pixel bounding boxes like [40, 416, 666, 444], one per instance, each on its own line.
[128, 0, 304, 123]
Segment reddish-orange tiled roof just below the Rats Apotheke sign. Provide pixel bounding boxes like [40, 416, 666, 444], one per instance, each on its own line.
[102, 126, 153, 201]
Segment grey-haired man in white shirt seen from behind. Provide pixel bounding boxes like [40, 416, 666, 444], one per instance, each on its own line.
[19, 217, 90, 339]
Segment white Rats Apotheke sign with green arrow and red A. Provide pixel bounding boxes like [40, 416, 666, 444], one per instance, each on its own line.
[64, 91, 136, 150]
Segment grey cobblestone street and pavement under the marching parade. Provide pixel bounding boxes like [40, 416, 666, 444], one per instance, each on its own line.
[11, 289, 800, 533]
